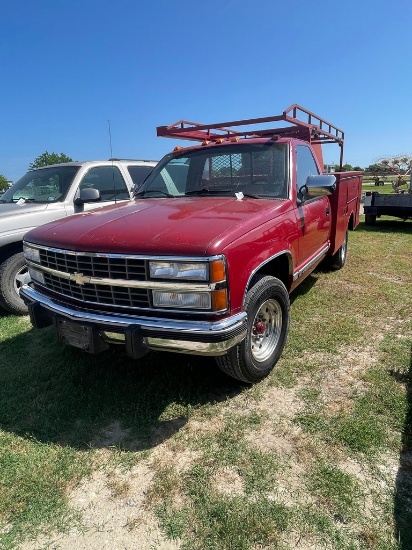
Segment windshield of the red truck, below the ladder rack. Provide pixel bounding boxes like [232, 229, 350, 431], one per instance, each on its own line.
[135, 142, 288, 198]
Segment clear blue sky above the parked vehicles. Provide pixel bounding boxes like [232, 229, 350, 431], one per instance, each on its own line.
[0, 0, 412, 181]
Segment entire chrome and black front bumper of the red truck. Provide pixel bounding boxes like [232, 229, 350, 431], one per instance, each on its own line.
[20, 284, 247, 358]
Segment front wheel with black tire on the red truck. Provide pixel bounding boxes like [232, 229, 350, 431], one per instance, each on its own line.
[216, 276, 290, 384]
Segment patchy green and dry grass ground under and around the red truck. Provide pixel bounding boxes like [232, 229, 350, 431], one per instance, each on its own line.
[0, 215, 412, 550]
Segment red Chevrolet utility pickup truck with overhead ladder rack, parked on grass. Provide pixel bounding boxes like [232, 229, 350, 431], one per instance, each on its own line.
[20, 105, 362, 383]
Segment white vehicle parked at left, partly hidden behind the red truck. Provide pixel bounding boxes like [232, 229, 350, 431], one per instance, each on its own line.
[0, 159, 157, 314]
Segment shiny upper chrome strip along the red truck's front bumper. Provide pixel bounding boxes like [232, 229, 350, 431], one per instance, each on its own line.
[20, 285, 247, 337]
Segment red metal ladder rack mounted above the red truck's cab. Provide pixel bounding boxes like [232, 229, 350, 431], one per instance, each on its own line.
[157, 103, 345, 166]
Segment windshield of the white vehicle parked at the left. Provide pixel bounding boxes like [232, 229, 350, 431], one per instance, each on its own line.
[0, 166, 80, 202]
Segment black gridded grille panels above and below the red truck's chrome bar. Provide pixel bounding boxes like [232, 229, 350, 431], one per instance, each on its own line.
[40, 249, 150, 309]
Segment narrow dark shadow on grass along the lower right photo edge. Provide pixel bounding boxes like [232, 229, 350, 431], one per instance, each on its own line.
[394, 347, 412, 550]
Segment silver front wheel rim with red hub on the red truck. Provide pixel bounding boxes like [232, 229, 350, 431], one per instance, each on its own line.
[250, 299, 282, 363]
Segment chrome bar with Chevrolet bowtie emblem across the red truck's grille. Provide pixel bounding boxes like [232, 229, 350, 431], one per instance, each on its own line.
[26, 259, 219, 292]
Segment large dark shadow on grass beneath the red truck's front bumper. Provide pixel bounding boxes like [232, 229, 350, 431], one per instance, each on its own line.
[0, 322, 244, 451]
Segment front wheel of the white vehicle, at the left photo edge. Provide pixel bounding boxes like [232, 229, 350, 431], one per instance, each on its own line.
[0, 252, 30, 315]
